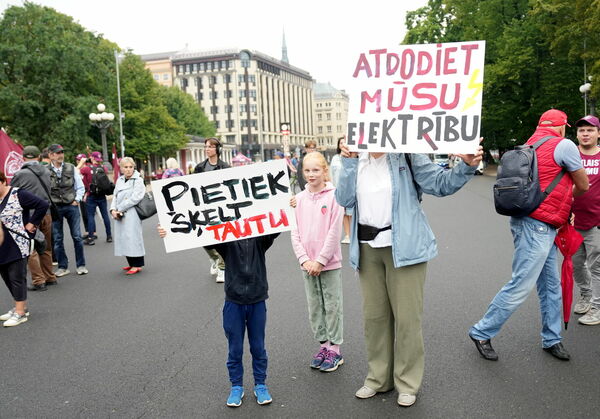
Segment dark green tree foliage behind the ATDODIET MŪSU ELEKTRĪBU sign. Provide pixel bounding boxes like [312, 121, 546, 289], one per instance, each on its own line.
[404, 0, 600, 149]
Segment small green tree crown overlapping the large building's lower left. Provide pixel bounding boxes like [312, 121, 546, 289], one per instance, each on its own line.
[160, 86, 216, 138]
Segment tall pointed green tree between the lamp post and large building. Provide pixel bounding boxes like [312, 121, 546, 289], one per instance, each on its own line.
[115, 53, 187, 159]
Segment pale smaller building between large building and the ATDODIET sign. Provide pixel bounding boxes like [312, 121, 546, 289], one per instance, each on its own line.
[313, 83, 348, 150]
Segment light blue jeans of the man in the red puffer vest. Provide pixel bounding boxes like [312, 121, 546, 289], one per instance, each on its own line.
[469, 217, 562, 348]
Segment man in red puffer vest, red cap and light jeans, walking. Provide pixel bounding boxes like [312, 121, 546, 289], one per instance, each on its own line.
[469, 109, 589, 361]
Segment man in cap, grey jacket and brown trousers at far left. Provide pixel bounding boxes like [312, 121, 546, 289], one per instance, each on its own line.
[10, 145, 56, 291]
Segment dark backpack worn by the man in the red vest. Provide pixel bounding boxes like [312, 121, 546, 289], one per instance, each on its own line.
[494, 136, 566, 217]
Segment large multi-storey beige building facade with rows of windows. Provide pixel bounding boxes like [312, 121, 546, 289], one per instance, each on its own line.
[171, 49, 314, 160]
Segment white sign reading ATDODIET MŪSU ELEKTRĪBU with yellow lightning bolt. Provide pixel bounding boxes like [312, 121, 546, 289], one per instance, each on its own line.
[346, 41, 485, 153]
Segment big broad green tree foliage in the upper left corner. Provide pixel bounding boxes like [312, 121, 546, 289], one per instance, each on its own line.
[0, 3, 116, 150]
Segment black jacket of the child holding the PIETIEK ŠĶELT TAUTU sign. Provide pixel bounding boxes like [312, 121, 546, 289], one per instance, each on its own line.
[207, 233, 279, 304]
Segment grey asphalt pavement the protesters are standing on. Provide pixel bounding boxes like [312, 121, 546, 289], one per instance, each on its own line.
[0, 176, 600, 419]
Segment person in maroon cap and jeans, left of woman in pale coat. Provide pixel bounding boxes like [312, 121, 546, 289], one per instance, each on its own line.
[80, 151, 115, 245]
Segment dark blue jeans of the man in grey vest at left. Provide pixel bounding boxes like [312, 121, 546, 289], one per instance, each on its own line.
[52, 205, 85, 269]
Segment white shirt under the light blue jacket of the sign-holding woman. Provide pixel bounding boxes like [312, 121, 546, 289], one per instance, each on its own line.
[356, 153, 392, 247]
